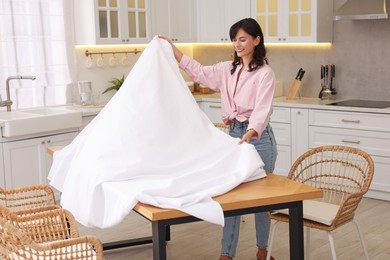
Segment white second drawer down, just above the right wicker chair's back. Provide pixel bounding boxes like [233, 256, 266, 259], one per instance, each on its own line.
[309, 126, 390, 157]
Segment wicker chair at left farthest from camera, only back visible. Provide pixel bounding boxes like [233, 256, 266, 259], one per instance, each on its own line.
[0, 185, 60, 211]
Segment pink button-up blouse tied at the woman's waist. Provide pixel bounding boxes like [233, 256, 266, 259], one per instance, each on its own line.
[179, 55, 275, 138]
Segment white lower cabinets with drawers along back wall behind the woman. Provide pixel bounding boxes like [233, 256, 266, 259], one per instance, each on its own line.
[199, 98, 390, 201]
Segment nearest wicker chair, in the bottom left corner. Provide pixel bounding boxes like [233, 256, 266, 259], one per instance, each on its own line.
[0, 217, 103, 260]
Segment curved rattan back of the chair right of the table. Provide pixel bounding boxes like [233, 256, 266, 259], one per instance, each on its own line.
[288, 145, 374, 227]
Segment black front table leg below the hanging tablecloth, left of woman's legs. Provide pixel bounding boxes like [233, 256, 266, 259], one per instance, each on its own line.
[152, 221, 167, 260]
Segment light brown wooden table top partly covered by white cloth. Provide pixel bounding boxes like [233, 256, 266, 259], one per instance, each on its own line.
[134, 174, 323, 221]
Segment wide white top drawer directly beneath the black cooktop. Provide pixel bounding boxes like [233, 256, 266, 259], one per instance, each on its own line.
[309, 110, 390, 132]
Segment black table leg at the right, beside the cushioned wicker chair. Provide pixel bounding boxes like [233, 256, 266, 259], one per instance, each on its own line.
[289, 201, 304, 260]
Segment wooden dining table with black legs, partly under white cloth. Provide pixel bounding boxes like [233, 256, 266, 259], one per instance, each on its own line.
[48, 146, 323, 260]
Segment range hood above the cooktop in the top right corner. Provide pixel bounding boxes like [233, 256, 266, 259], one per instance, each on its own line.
[333, 0, 388, 21]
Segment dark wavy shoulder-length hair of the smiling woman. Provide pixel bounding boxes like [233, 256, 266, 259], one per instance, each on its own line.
[229, 18, 268, 74]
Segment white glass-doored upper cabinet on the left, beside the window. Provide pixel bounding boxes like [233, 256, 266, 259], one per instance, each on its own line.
[73, 0, 151, 45]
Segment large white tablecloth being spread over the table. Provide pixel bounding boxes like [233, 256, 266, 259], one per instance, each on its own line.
[49, 37, 266, 228]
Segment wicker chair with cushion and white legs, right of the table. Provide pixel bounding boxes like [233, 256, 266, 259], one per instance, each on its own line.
[267, 146, 374, 259]
